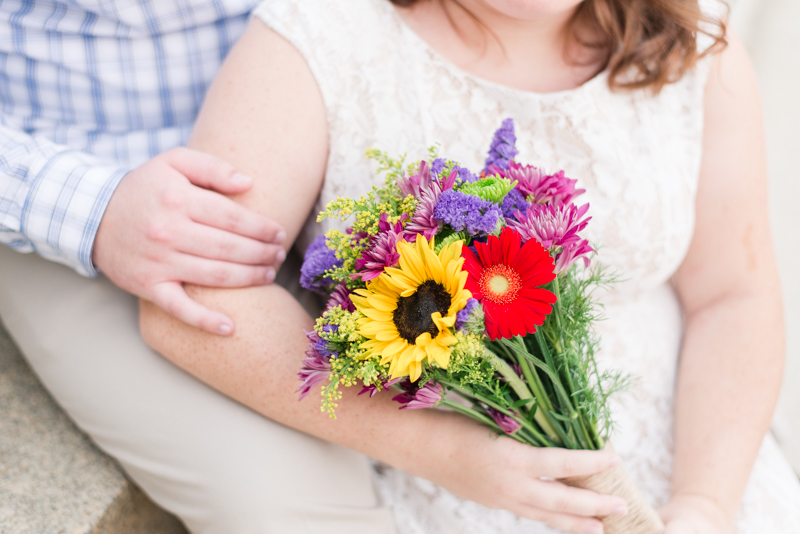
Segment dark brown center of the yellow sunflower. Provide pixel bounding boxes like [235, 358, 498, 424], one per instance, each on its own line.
[393, 280, 451, 343]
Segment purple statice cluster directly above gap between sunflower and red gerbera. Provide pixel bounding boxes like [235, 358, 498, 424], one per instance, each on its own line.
[433, 189, 501, 235]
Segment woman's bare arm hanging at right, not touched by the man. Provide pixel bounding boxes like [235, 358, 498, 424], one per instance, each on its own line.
[668, 32, 784, 532]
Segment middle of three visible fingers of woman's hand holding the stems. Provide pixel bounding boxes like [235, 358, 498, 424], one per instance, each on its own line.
[530, 480, 628, 517]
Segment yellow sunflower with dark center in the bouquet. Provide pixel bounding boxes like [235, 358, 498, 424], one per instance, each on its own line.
[350, 235, 472, 382]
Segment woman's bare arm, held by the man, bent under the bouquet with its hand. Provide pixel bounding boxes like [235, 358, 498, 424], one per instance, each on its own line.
[141, 20, 620, 532]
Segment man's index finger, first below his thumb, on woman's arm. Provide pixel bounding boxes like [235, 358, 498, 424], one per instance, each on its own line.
[188, 191, 286, 245]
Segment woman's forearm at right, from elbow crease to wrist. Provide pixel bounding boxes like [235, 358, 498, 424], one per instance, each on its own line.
[673, 291, 783, 522]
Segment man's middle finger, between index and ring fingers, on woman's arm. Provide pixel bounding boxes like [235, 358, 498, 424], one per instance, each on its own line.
[175, 223, 286, 269]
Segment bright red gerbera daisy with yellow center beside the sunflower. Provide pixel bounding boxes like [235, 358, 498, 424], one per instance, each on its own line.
[462, 228, 556, 341]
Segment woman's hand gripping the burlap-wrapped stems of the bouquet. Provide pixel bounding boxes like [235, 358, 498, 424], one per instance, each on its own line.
[425, 417, 628, 534]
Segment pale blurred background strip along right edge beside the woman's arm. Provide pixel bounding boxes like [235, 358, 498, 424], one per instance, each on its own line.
[730, 0, 800, 474]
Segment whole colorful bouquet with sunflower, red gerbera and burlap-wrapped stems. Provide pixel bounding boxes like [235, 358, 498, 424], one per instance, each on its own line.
[298, 119, 663, 534]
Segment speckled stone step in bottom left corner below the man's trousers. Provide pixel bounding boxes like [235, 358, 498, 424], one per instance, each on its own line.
[0, 325, 186, 534]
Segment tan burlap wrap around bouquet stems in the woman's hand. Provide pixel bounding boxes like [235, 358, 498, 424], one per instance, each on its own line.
[561, 465, 664, 534]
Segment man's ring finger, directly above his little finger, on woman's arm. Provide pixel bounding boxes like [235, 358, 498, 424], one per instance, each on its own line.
[175, 254, 276, 287]
